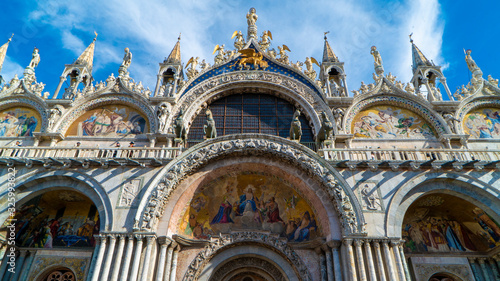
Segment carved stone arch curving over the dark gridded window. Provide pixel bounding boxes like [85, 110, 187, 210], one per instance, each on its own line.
[168, 71, 333, 134]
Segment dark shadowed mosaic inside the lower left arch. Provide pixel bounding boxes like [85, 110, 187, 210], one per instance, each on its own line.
[4, 190, 100, 248]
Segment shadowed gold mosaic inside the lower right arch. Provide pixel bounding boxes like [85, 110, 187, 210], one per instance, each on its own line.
[402, 194, 500, 252]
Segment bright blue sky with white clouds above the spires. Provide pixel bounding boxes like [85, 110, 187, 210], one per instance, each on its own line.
[0, 0, 500, 98]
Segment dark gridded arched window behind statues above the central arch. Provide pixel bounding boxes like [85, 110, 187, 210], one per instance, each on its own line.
[188, 93, 314, 148]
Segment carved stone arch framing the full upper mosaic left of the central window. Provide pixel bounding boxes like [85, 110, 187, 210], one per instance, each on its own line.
[55, 94, 157, 133]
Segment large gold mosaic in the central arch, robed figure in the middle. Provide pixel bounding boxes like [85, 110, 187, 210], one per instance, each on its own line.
[179, 172, 319, 242]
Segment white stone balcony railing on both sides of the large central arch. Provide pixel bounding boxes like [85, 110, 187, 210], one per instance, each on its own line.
[0, 147, 500, 168]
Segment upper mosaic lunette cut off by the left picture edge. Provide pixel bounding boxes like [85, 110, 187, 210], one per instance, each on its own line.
[0, 107, 42, 137]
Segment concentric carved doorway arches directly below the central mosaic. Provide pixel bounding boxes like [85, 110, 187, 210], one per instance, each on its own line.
[182, 232, 312, 281]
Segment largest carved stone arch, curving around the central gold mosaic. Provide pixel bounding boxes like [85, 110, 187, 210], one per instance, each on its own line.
[134, 134, 364, 235]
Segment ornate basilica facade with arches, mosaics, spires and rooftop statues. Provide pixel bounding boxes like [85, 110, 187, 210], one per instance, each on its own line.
[0, 9, 500, 281]
